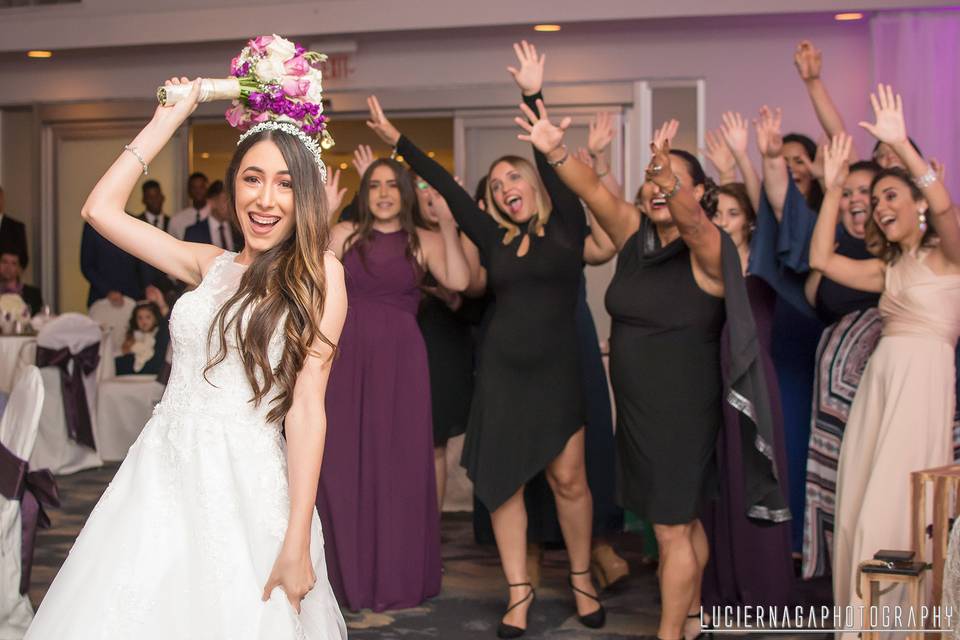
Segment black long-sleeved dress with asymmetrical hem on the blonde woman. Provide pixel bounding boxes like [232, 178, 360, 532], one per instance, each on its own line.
[397, 132, 585, 511]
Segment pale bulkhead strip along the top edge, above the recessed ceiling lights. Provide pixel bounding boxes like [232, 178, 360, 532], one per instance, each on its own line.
[0, 0, 952, 51]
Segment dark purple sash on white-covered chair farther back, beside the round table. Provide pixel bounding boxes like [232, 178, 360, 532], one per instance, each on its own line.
[37, 342, 100, 450]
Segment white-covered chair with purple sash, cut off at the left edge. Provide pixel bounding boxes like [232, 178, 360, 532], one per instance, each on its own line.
[0, 366, 49, 640]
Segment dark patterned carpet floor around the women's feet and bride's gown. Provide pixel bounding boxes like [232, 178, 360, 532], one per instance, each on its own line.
[30, 464, 822, 640]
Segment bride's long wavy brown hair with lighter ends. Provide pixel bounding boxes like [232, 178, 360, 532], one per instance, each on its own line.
[203, 129, 336, 422]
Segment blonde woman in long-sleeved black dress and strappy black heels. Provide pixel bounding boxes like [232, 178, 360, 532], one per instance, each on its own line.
[368, 46, 605, 637]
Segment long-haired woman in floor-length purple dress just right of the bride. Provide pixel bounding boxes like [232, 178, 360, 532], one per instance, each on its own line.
[317, 159, 470, 611]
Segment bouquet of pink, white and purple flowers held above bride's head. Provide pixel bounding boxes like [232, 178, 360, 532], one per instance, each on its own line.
[157, 35, 333, 149]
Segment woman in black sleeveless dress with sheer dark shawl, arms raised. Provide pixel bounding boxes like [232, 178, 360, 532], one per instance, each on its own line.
[517, 101, 784, 640]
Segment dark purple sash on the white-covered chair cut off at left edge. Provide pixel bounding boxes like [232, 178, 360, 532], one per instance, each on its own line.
[0, 443, 60, 594]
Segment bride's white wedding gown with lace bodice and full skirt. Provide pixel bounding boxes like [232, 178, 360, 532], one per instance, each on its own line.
[26, 252, 347, 640]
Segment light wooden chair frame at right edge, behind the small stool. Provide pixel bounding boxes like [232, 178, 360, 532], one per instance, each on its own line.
[910, 464, 960, 607]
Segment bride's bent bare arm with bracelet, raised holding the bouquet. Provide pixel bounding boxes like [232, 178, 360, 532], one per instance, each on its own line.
[80, 78, 222, 285]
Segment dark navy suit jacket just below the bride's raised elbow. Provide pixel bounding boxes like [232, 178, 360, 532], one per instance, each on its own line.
[80, 224, 144, 306]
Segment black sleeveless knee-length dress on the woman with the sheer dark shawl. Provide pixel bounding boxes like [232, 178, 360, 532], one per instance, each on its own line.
[606, 231, 725, 524]
